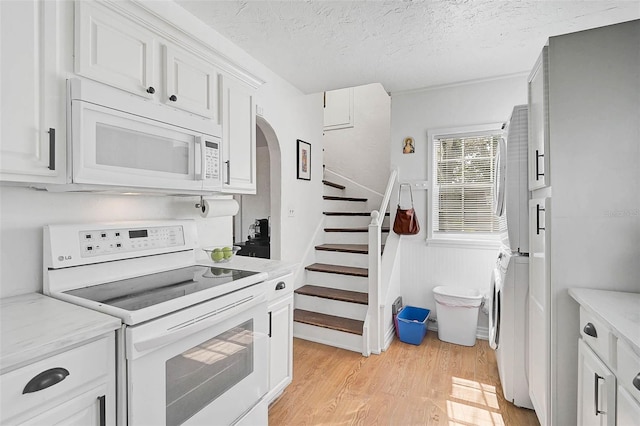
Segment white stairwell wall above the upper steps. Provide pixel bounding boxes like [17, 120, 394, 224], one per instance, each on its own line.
[323, 83, 391, 193]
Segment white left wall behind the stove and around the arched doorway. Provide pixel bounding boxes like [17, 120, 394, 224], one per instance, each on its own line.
[0, 1, 322, 297]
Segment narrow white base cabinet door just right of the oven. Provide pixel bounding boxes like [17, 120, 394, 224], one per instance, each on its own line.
[267, 294, 293, 402]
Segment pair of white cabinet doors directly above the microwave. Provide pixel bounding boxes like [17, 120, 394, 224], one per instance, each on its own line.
[75, 1, 220, 124]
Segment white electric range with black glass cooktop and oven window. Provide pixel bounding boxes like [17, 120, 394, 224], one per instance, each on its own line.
[43, 220, 269, 425]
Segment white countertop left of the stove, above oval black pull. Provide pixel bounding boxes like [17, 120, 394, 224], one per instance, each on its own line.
[0, 293, 121, 374]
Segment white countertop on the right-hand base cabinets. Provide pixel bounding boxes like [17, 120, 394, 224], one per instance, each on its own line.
[569, 288, 640, 354]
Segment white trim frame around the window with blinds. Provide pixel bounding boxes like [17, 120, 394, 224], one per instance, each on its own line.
[426, 123, 504, 250]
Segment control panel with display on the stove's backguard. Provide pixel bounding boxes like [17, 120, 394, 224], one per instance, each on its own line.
[79, 225, 185, 257]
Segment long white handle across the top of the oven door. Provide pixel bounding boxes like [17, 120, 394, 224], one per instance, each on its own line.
[133, 295, 267, 352]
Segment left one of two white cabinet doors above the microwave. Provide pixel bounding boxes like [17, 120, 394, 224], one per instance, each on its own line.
[75, 1, 158, 98]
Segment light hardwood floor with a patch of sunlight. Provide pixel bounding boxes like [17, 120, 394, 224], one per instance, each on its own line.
[269, 331, 539, 426]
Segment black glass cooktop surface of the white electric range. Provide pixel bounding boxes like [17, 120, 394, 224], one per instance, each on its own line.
[64, 265, 258, 311]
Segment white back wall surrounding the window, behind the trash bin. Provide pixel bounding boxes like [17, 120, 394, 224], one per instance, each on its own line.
[390, 75, 527, 332]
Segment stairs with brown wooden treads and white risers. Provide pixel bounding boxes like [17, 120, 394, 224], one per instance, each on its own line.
[293, 180, 389, 353]
